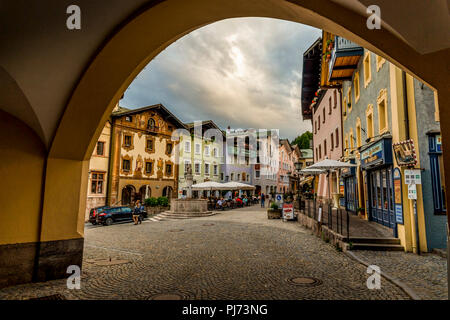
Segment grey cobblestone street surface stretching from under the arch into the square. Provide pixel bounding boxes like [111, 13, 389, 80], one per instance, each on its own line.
[0, 206, 445, 299]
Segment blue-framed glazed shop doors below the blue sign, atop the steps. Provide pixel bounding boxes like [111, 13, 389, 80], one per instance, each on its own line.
[369, 168, 395, 228]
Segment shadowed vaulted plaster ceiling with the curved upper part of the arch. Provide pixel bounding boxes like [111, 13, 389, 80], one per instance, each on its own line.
[0, 0, 450, 152]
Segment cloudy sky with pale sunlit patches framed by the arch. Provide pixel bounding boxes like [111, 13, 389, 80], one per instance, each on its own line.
[120, 18, 321, 139]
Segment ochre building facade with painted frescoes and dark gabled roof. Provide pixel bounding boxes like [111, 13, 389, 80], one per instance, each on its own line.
[107, 104, 186, 205]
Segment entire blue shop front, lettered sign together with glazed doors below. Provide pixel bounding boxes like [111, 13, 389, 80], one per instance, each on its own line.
[360, 136, 397, 233]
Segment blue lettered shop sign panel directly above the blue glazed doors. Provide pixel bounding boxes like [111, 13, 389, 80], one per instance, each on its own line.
[361, 138, 392, 169]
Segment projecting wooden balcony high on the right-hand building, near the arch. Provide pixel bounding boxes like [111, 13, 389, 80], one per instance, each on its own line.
[328, 36, 364, 81]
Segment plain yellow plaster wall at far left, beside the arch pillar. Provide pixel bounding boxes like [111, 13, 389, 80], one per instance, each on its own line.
[0, 110, 46, 245]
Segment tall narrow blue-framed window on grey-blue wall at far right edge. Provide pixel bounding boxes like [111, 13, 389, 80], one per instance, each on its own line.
[428, 135, 447, 214]
